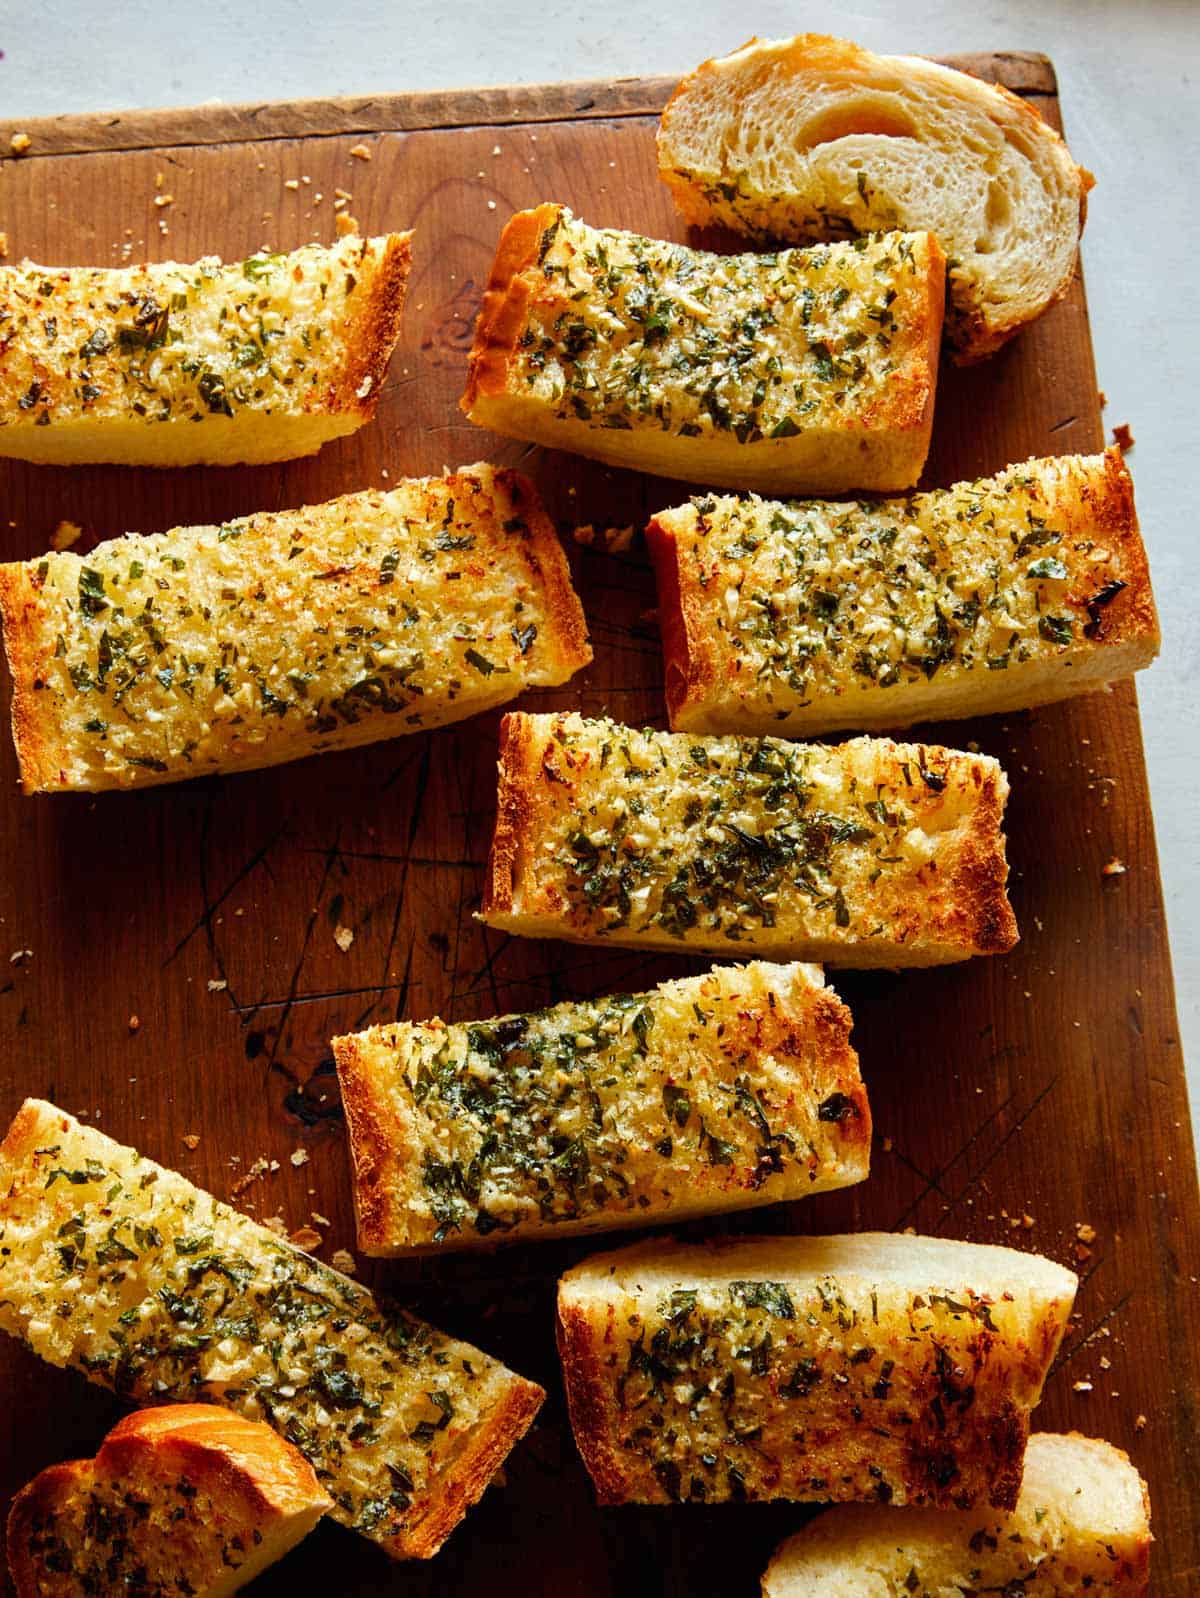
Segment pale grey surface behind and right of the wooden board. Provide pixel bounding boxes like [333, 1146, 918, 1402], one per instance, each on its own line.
[0, 0, 1200, 1137]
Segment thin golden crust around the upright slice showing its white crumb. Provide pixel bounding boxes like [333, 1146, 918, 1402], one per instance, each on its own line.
[655, 34, 1096, 366]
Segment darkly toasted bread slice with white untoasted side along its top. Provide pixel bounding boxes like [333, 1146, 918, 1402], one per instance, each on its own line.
[558, 1232, 1077, 1509]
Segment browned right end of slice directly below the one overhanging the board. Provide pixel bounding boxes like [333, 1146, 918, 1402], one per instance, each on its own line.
[939, 745, 1019, 954]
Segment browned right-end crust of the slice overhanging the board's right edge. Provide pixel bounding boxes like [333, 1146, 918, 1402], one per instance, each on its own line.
[1071, 444, 1162, 671]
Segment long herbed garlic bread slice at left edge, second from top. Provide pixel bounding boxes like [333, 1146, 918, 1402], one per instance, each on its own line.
[0, 465, 591, 793]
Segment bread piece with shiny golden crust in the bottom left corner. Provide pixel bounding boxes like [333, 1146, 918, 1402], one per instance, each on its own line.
[8, 1405, 334, 1598]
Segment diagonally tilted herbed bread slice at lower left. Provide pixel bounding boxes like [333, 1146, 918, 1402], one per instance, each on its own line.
[0, 1099, 545, 1560]
